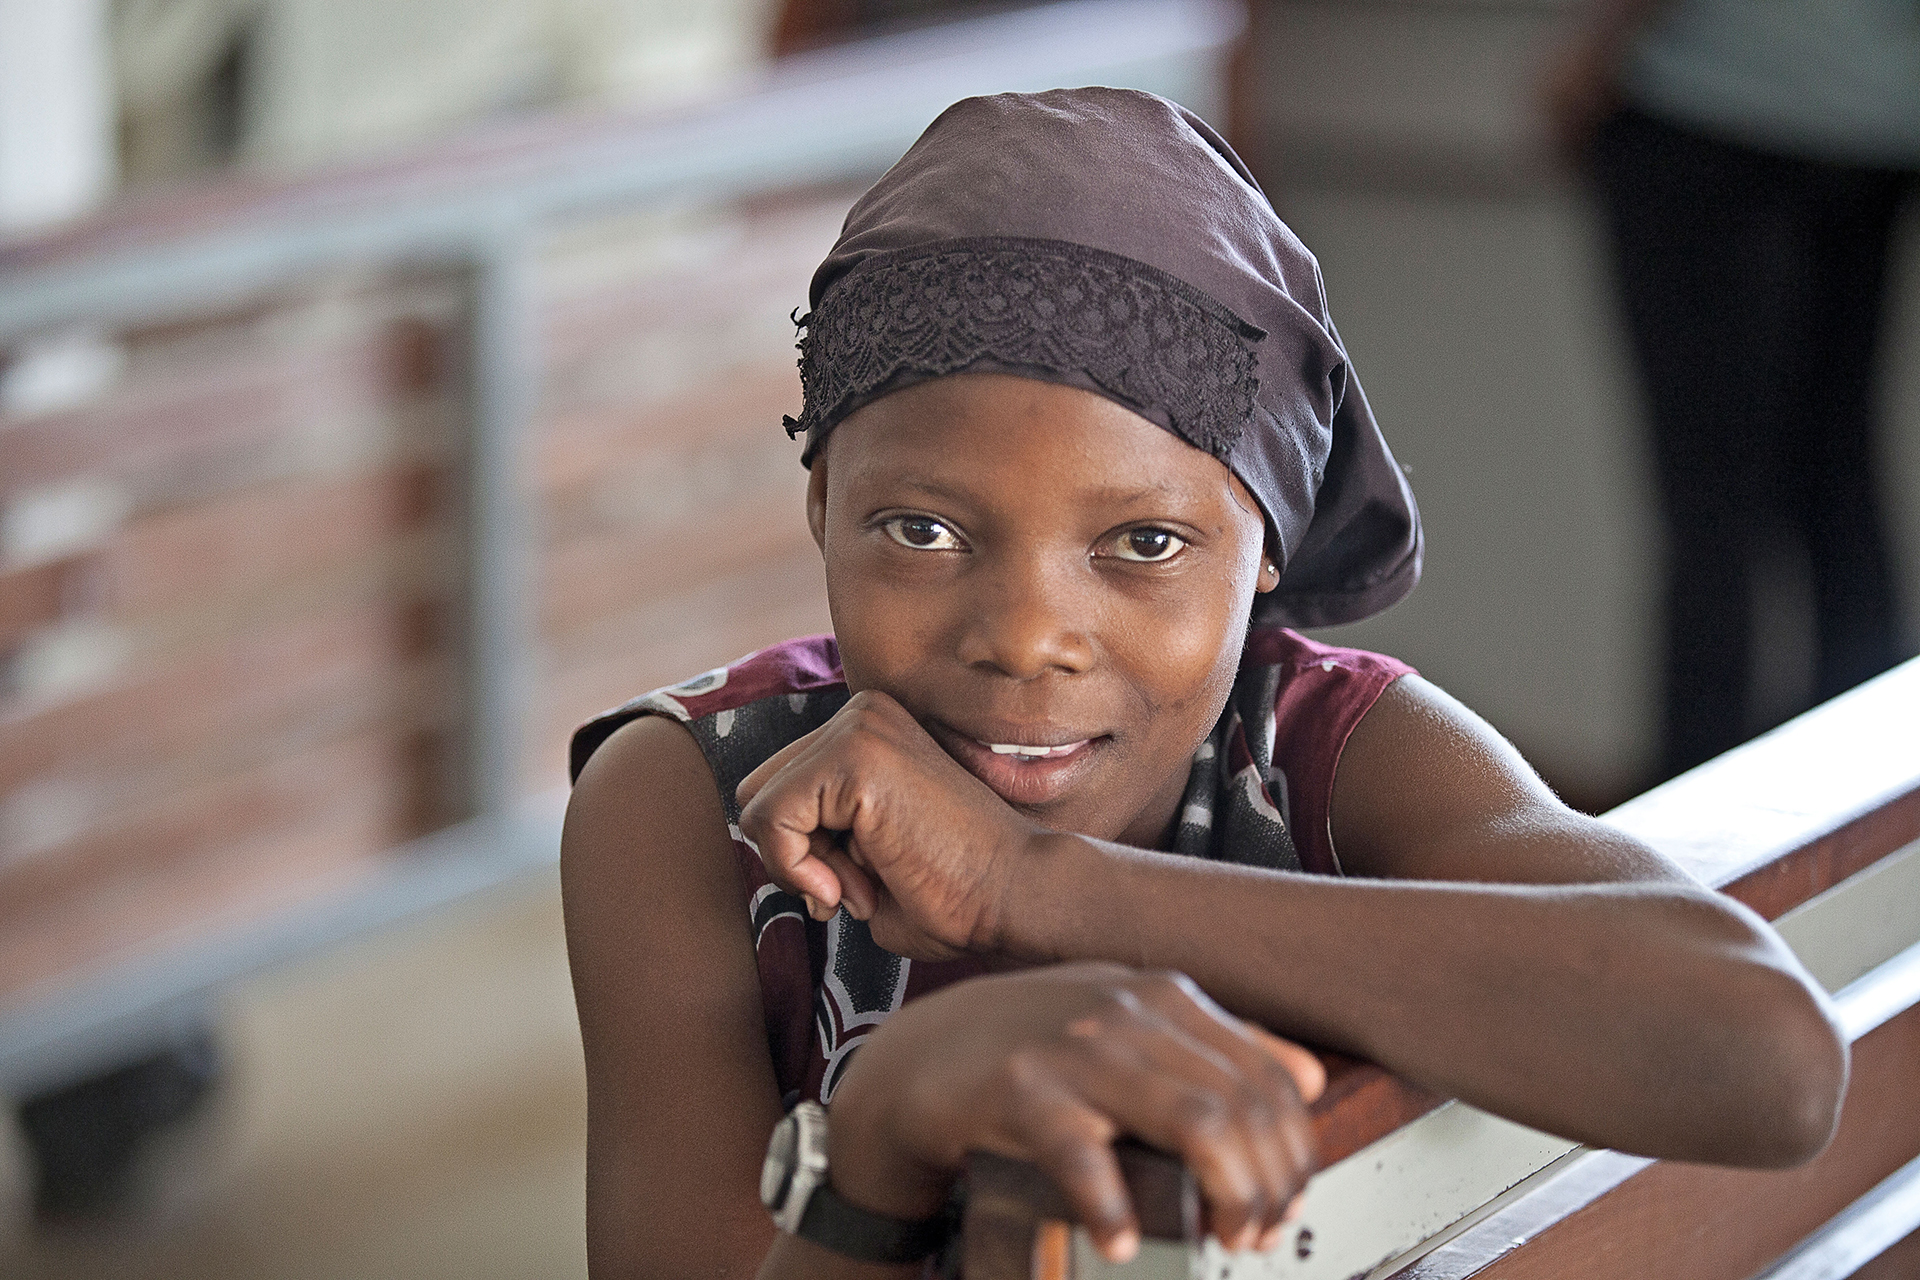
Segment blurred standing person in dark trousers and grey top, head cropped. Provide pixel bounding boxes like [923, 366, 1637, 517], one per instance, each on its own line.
[1542, 0, 1920, 775]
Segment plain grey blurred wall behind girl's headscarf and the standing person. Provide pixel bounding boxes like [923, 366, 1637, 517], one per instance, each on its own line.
[1248, 0, 1920, 810]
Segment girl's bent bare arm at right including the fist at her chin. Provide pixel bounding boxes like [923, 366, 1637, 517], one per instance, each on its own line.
[741, 677, 1847, 1165]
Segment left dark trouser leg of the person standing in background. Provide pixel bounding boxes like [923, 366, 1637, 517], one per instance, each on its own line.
[1594, 111, 1789, 775]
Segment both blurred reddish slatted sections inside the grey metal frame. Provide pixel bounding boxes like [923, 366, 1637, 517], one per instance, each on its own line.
[0, 192, 851, 998]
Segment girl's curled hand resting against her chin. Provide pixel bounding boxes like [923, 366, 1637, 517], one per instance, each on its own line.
[737, 691, 1044, 960]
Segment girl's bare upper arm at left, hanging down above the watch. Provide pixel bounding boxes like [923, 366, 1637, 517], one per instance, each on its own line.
[561, 716, 799, 1280]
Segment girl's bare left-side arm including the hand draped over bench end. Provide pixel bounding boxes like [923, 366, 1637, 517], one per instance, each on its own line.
[561, 718, 1323, 1280]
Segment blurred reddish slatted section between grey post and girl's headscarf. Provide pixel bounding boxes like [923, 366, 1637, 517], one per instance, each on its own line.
[528, 190, 856, 785]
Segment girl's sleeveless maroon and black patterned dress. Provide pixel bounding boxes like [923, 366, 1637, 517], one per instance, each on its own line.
[570, 628, 1413, 1107]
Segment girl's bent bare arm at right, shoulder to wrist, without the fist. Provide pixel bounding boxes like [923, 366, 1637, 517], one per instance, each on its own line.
[1004, 676, 1847, 1167]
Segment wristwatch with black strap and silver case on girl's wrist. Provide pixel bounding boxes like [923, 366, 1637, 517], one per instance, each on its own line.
[760, 1102, 950, 1263]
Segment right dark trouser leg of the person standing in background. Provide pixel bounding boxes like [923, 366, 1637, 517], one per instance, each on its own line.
[1786, 169, 1907, 700]
